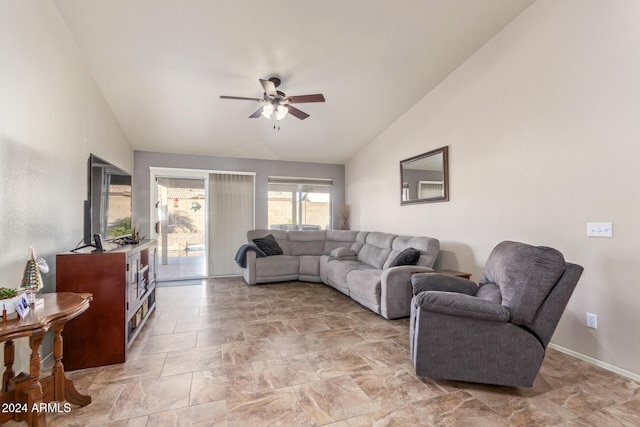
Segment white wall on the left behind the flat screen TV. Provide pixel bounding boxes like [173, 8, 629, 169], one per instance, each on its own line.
[0, 0, 133, 371]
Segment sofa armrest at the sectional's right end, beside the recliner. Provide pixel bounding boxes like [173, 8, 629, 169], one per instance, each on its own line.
[380, 265, 433, 319]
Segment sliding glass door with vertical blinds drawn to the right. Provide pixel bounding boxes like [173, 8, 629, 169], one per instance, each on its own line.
[151, 168, 255, 281]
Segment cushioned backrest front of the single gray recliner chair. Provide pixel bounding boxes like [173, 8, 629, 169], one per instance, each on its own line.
[479, 241, 565, 326]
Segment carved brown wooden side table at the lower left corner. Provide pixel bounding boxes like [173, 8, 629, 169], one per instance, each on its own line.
[0, 292, 93, 426]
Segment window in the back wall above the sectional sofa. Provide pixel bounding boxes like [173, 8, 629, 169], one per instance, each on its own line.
[268, 177, 332, 230]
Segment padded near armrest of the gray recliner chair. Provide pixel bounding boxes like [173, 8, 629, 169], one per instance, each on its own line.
[414, 291, 511, 323]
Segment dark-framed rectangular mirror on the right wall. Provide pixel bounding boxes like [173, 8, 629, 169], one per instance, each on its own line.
[400, 147, 449, 205]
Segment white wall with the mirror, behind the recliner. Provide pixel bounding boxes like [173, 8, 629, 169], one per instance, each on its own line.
[346, 0, 640, 374]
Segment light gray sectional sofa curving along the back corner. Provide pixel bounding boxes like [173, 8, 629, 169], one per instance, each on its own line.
[242, 230, 440, 319]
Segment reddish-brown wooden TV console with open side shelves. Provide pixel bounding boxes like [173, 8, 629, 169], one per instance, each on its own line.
[56, 240, 156, 371]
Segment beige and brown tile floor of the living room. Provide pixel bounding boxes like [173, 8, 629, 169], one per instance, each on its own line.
[32, 278, 640, 427]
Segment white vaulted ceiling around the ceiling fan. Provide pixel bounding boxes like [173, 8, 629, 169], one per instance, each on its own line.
[54, 0, 533, 164]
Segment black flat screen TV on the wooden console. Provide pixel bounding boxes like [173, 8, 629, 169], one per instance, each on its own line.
[84, 154, 131, 245]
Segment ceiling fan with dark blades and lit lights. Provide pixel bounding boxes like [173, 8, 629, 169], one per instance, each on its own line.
[220, 77, 324, 121]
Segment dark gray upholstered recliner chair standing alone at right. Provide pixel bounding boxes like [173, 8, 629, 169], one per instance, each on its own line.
[410, 241, 583, 387]
